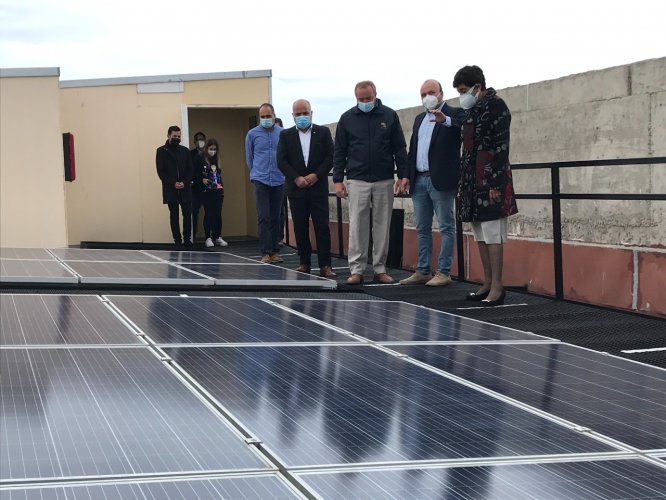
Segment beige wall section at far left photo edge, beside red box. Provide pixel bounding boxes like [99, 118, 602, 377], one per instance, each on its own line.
[0, 68, 67, 247]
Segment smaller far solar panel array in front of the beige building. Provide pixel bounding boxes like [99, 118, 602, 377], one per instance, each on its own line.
[0, 248, 337, 289]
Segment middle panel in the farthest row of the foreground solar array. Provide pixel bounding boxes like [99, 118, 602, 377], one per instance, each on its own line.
[110, 295, 353, 344]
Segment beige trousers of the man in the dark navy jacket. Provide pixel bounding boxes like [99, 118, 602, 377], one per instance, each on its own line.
[347, 179, 394, 274]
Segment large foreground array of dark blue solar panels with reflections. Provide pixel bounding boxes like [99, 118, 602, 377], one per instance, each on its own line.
[0, 294, 666, 500]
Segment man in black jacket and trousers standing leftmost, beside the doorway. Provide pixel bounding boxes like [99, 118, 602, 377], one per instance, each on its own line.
[155, 125, 194, 247]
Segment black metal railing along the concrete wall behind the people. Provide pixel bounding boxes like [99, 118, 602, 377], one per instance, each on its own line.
[328, 156, 666, 299]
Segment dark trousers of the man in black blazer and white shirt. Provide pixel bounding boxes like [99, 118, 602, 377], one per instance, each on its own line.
[289, 191, 331, 267]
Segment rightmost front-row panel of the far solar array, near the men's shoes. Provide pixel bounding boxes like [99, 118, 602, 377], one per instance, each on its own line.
[182, 263, 337, 288]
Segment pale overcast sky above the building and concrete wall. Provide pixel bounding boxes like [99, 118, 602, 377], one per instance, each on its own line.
[0, 0, 666, 126]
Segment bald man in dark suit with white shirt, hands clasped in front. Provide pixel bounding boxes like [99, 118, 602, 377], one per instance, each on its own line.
[277, 99, 335, 278]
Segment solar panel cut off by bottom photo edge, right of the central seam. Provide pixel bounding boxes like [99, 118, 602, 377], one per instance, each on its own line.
[301, 460, 666, 500]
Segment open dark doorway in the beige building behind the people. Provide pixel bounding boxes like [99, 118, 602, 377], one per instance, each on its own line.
[183, 106, 257, 240]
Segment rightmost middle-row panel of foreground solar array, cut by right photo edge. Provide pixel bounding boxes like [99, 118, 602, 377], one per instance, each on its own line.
[391, 344, 666, 449]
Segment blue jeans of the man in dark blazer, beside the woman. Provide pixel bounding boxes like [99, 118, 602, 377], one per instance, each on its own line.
[412, 174, 456, 274]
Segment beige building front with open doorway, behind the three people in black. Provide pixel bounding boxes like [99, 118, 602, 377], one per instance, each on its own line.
[60, 71, 270, 244]
